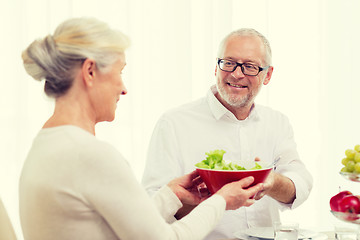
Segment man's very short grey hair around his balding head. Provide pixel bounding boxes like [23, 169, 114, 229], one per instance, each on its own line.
[218, 28, 272, 65]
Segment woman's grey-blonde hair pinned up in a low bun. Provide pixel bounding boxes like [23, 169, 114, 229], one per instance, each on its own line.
[22, 18, 130, 98]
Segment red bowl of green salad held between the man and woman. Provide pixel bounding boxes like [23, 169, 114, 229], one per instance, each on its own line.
[196, 167, 272, 194]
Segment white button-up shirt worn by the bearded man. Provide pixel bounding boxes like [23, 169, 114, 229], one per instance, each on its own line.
[142, 86, 312, 239]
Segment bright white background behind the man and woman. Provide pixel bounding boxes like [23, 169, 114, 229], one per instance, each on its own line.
[0, 0, 360, 239]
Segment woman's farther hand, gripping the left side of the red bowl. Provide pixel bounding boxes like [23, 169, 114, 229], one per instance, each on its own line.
[168, 170, 210, 205]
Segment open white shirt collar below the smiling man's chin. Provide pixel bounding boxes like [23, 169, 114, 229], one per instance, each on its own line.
[207, 85, 259, 121]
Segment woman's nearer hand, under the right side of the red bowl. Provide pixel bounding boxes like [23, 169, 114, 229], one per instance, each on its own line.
[216, 177, 264, 210]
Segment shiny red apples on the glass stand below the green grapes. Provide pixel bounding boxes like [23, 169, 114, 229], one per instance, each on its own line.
[330, 191, 360, 214]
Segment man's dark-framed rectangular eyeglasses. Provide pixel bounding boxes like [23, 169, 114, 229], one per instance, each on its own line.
[218, 58, 270, 76]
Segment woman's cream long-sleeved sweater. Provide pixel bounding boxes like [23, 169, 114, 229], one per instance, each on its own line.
[20, 125, 225, 240]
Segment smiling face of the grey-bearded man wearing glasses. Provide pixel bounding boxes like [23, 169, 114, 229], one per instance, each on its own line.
[215, 36, 273, 109]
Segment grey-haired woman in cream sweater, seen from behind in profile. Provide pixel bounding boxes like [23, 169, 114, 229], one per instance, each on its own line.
[20, 18, 263, 240]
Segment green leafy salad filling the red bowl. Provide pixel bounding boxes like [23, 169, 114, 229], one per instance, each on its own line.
[195, 150, 262, 170]
